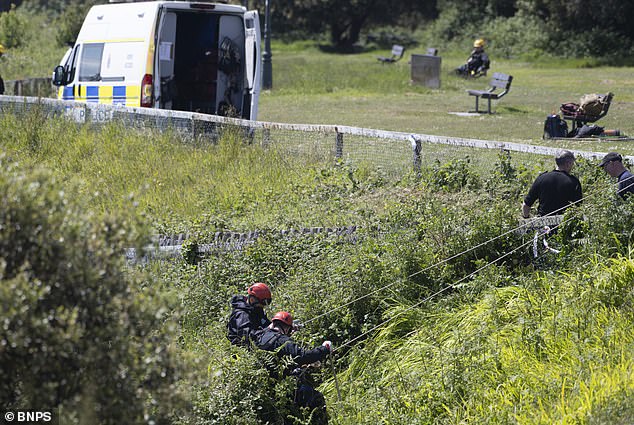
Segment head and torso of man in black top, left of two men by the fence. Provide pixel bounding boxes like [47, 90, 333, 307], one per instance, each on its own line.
[522, 150, 583, 218]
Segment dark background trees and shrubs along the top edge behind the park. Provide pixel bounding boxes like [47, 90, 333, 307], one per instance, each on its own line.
[0, 0, 634, 59]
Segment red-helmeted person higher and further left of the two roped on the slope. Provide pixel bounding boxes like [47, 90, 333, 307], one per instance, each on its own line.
[227, 282, 271, 346]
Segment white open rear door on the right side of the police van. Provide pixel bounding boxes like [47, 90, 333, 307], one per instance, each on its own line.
[243, 10, 262, 120]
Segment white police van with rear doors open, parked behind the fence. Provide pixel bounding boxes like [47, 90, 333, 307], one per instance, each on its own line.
[53, 0, 261, 120]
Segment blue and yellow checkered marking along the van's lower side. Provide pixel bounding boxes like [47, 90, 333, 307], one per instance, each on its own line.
[58, 86, 141, 106]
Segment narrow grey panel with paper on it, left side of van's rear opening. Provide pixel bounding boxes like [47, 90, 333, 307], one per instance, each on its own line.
[154, 9, 176, 109]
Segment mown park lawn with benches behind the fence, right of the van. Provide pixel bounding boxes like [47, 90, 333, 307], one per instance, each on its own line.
[258, 43, 634, 154]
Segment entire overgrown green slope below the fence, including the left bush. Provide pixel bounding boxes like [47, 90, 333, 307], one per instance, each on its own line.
[0, 108, 634, 424]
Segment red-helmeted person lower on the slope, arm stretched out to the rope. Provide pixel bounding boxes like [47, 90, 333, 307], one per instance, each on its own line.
[256, 311, 332, 423]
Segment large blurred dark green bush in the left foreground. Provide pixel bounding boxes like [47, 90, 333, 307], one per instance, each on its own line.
[0, 159, 185, 424]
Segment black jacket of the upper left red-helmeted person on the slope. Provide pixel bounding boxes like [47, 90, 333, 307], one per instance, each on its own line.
[227, 295, 271, 345]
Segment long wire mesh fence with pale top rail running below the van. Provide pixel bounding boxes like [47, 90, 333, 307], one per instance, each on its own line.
[0, 96, 616, 184]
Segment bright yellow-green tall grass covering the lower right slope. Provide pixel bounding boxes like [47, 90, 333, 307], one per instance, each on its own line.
[327, 258, 634, 424]
